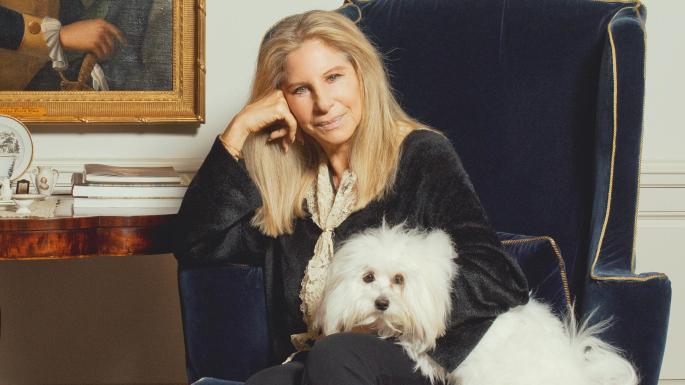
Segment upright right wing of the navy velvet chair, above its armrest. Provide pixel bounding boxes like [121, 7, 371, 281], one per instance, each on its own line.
[588, 3, 658, 278]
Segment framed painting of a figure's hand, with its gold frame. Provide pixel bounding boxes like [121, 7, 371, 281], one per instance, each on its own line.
[0, 0, 205, 124]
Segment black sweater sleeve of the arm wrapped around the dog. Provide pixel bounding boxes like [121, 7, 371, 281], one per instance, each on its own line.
[404, 131, 528, 371]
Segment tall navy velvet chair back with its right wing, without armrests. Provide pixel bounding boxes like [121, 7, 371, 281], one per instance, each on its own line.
[341, 0, 644, 295]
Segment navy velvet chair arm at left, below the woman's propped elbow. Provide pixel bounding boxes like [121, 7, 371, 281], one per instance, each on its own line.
[178, 265, 270, 383]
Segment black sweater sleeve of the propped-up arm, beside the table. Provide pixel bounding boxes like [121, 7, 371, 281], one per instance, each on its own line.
[173, 139, 272, 266]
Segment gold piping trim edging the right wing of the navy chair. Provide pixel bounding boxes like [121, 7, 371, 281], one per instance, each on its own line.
[590, 6, 667, 282]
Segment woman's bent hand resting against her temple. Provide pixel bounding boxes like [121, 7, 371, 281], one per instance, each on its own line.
[221, 90, 297, 152]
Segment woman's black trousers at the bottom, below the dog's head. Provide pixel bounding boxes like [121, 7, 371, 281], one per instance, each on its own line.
[245, 333, 430, 385]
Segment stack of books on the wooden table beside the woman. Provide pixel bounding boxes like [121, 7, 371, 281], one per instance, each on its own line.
[71, 164, 188, 214]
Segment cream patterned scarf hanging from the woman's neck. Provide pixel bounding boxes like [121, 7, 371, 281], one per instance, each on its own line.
[291, 164, 357, 351]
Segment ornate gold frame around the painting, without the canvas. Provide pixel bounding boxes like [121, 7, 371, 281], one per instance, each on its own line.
[0, 0, 206, 124]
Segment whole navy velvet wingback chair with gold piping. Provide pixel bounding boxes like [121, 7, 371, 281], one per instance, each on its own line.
[174, 0, 671, 385]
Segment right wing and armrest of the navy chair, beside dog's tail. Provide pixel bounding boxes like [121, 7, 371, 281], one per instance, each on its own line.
[578, 8, 671, 385]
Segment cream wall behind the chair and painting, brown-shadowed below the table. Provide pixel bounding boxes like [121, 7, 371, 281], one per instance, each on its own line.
[0, 0, 685, 385]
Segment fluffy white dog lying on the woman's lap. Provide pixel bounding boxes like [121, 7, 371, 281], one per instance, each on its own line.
[314, 225, 637, 385]
